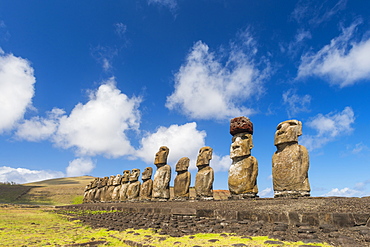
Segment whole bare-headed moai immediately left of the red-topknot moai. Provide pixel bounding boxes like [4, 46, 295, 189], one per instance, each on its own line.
[195, 147, 214, 200]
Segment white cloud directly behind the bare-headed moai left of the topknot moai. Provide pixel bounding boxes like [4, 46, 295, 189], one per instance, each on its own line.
[136, 122, 206, 169]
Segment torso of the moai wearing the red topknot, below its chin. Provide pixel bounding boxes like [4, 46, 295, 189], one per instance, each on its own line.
[228, 156, 258, 194]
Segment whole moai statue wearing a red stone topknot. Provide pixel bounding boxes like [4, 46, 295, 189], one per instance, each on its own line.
[228, 117, 258, 199]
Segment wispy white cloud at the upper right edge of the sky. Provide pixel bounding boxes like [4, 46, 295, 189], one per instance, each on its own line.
[297, 20, 370, 88]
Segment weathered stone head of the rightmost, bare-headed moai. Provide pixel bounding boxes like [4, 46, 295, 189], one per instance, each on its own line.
[274, 120, 302, 146]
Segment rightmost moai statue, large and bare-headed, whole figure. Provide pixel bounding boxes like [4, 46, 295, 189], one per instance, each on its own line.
[272, 120, 311, 197]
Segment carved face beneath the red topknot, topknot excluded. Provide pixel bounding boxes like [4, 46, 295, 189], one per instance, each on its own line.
[230, 132, 253, 159]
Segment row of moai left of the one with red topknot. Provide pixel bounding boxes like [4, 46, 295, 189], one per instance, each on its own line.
[84, 146, 214, 203]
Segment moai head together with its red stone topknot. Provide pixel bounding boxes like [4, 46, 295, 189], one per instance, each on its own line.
[230, 117, 253, 159]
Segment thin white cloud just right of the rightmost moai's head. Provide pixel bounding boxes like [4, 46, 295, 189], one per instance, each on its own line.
[301, 107, 355, 150]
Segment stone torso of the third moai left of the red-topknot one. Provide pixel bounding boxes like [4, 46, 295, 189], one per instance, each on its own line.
[153, 165, 171, 199]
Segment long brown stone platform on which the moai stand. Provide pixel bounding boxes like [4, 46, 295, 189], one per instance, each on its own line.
[58, 197, 370, 246]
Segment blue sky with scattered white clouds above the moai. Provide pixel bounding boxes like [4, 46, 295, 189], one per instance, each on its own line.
[0, 0, 370, 197]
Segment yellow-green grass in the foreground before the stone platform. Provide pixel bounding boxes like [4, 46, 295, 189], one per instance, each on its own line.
[0, 205, 329, 246]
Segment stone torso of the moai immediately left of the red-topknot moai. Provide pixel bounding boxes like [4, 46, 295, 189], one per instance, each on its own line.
[195, 166, 214, 197]
